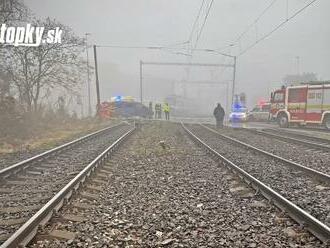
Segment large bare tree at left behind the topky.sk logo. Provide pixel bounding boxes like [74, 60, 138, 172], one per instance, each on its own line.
[4, 18, 86, 111]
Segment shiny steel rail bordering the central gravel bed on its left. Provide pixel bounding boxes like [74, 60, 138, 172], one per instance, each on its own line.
[0, 126, 136, 248]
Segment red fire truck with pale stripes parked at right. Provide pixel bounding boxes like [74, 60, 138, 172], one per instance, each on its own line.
[270, 81, 330, 129]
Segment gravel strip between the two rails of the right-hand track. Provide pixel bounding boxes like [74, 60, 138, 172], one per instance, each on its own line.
[190, 125, 330, 228]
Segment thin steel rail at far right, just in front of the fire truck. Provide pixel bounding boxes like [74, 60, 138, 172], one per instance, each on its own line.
[248, 128, 330, 151]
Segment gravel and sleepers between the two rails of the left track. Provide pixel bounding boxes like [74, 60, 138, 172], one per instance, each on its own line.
[0, 125, 132, 244]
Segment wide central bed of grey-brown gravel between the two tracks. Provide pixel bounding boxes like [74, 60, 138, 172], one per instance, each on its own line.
[31, 122, 325, 247]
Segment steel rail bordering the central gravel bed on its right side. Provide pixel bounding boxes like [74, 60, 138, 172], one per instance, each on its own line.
[181, 123, 330, 243]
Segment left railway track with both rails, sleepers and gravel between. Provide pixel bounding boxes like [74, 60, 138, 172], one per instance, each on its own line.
[0, 123, 134, 247]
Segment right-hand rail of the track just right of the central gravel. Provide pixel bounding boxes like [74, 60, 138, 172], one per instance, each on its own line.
[200, 124, 330, 183]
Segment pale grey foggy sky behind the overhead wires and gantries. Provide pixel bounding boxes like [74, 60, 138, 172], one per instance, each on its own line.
[25, 0, 330, 109]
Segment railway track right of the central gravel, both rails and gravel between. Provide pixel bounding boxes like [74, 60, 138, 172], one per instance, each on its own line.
[183, 125, 330, 242]
